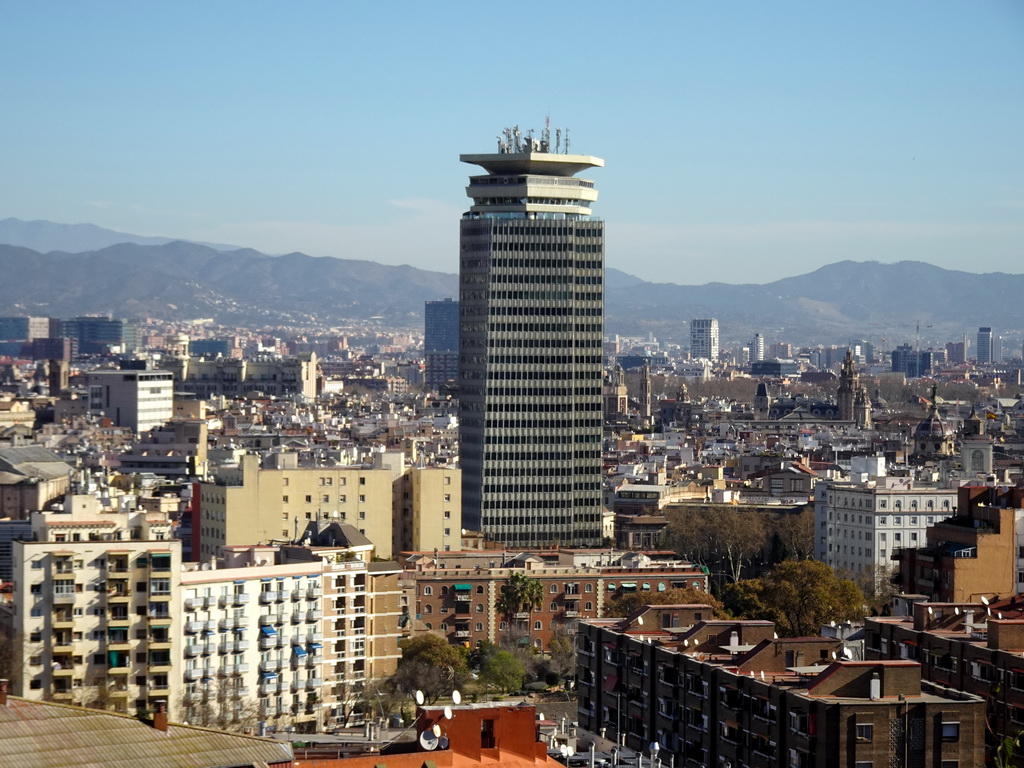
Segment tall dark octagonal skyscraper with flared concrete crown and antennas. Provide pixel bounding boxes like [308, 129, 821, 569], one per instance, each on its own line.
[459, 128, 604, 546]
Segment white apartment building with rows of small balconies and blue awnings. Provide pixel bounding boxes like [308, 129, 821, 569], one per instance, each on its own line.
[177, 547, 324, 732]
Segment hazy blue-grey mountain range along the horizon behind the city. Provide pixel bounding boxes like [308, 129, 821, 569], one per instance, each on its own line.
[0, 219, 1024, 347]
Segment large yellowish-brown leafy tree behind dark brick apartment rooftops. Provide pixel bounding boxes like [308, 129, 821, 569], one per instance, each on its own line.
[725, 560, 864, 637]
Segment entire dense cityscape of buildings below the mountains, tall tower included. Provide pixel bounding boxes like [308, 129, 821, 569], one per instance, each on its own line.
[0, 151, 1024, 768]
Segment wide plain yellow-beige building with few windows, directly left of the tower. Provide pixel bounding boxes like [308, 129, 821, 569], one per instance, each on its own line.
[193, 453, 462, 559]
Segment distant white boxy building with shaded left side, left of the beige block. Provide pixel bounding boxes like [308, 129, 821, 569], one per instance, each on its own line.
[88, 371, 174, 434]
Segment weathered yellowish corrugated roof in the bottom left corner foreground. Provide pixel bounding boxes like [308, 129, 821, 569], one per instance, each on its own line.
[0, 696, 292, 768]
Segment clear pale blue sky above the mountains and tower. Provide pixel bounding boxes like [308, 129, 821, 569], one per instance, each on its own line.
[0, 0, 1024, 284]
